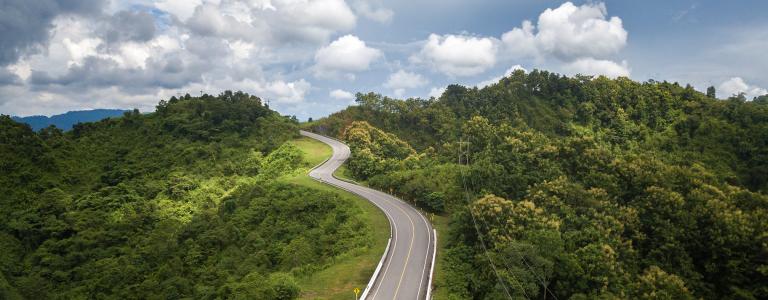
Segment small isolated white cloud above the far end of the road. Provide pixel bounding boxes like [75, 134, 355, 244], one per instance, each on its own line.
[315, 35, 382, 77]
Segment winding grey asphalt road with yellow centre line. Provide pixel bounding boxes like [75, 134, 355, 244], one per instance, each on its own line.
[301, 131, 434, 300]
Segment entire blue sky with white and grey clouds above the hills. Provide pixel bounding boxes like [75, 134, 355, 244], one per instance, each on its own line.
[0, 0, 768, 119]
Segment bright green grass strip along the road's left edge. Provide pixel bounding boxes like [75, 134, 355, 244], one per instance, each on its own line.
[281, 137, 389, 299]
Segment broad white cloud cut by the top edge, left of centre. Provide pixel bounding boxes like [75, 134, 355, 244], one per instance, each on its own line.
[172, 0, 357, 45]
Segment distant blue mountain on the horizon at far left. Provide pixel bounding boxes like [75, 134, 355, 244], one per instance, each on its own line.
[13, 109, 127, 131]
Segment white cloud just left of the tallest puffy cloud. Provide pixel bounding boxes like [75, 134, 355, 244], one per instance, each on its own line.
[411, 34, 498, 76]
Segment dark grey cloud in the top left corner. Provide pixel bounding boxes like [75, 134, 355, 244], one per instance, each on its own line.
[0, 0, 104, 66]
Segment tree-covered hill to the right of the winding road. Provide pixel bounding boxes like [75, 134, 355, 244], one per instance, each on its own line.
[307, 71, 768, 299]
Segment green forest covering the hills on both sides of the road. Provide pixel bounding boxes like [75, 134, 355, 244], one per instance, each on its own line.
[0, 70, 768, 299]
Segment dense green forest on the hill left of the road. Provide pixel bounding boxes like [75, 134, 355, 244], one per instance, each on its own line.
[0, 92, 370, 299]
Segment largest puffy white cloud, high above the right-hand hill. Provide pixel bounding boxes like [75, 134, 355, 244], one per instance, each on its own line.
[501, 2, 627, 61]
